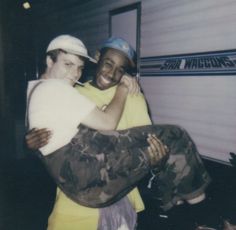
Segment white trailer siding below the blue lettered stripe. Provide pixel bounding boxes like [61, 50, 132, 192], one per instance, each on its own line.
[141, 76, 236, 161]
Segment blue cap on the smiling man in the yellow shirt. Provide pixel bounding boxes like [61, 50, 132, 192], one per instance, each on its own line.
[100, 37, 135, 67]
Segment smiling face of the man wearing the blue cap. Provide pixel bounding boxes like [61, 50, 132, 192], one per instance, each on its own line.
[93, 49, 129, 90]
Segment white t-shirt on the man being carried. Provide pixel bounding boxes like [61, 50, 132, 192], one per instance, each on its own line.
[27, 79, 96, 155]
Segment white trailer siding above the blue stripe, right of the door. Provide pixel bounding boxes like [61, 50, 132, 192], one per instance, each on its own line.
[141, 0, 236, 57]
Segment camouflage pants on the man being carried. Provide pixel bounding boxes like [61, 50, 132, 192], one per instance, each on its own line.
[41, 125, 210, 210]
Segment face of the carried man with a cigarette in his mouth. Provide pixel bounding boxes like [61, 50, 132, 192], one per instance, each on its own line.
[45, 52, 84, 85]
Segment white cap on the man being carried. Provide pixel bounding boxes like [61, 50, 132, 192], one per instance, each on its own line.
[47, 34, 96, 62]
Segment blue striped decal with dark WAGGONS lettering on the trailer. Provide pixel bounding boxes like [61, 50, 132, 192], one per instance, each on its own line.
[141, 50, 236, 76]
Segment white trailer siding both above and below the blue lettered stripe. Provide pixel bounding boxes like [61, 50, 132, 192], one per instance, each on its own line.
[141, 0, 236, 164]
